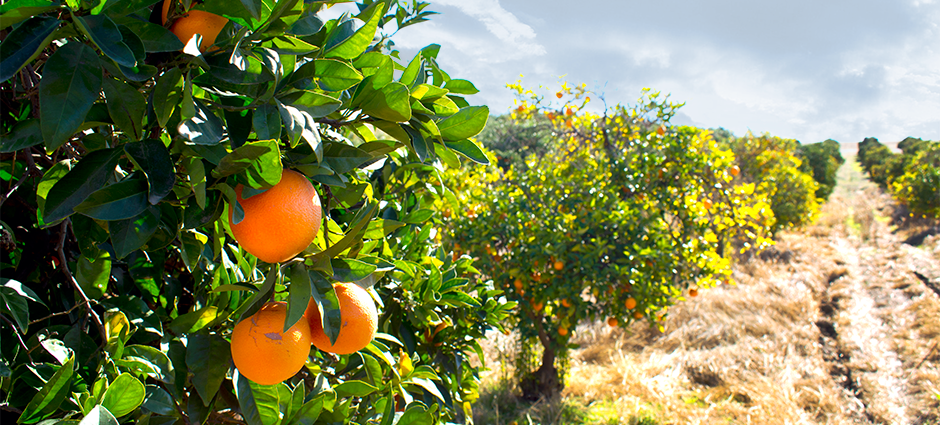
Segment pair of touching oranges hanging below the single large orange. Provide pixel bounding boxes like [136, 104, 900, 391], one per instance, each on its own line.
[231, 283, 378, 385]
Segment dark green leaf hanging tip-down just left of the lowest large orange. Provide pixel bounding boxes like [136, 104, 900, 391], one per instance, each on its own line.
[186, 333, 232, 406]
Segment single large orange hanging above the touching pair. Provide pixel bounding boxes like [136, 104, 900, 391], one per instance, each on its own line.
[228, 170, 321, 263]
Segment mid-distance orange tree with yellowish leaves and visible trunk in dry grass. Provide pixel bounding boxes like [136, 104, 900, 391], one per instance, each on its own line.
[443, 85, 772, 399]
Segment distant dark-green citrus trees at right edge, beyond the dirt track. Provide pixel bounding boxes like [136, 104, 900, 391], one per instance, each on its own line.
[858, 137, 940, 217]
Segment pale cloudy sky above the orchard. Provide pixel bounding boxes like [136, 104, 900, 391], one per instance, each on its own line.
[330, 0, 940, 143]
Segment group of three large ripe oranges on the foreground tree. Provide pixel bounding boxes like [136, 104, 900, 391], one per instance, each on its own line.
[229, 170, 378, 385]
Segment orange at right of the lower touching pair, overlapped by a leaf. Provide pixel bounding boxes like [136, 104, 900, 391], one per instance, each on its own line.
[306, 283, 380, 354]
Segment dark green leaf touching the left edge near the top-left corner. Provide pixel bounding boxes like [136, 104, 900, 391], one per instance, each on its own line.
[0, 15, 60, 82]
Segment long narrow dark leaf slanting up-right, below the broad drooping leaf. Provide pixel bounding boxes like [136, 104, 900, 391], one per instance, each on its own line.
[43, 147, 123, 224]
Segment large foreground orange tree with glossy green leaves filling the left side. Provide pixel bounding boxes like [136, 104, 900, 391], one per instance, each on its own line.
[0, 0, 512, 424]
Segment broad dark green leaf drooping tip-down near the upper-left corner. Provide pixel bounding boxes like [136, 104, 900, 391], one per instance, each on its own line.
[39, 43, 102, 151]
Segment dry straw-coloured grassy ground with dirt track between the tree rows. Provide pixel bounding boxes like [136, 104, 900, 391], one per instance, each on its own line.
[474, 156, 940, 424]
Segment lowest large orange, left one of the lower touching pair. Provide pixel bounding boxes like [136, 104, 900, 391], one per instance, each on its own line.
[231, 302, 310, 385]
